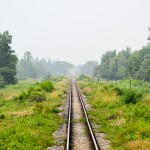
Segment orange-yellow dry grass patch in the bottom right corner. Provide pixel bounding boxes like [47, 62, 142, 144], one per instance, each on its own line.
[125, 140, 150, 150]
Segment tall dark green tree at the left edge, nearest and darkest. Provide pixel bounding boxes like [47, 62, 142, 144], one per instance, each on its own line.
[0, 31, 17, 84]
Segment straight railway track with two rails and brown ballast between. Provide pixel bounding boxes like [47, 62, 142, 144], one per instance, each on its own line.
[66, 80, 100, 150]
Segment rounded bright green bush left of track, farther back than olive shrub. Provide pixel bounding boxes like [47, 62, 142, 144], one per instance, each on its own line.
[39, 81, 54, 92]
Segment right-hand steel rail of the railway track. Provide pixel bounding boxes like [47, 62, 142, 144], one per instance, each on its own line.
[75, 82, 100, 150]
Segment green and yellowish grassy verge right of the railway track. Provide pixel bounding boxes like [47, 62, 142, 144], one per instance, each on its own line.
[79, 79, 150, 150]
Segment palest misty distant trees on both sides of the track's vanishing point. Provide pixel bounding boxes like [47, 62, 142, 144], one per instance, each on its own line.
[17, 51, 98, 80]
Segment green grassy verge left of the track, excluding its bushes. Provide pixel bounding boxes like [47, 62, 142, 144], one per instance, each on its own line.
[0, 79, 67, 150]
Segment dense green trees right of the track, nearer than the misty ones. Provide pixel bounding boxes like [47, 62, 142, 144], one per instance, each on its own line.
[94, 44, 150, 81]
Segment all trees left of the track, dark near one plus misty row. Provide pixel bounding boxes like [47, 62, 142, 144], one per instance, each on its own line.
[0, 31, 74, 88]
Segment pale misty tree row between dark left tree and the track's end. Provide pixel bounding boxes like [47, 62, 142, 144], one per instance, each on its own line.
[17, 51, 74, 80]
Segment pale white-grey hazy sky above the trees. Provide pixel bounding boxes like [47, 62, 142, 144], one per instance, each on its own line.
[0, 0, 150, 64]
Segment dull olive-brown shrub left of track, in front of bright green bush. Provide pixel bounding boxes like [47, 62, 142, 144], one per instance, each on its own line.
[30, 91, 46, 102]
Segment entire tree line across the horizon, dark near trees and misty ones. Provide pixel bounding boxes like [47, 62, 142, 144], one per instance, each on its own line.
[0, 28, 150, 88]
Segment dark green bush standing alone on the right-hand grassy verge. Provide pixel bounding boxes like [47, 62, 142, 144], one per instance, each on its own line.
[121, 89, 143, 104]
